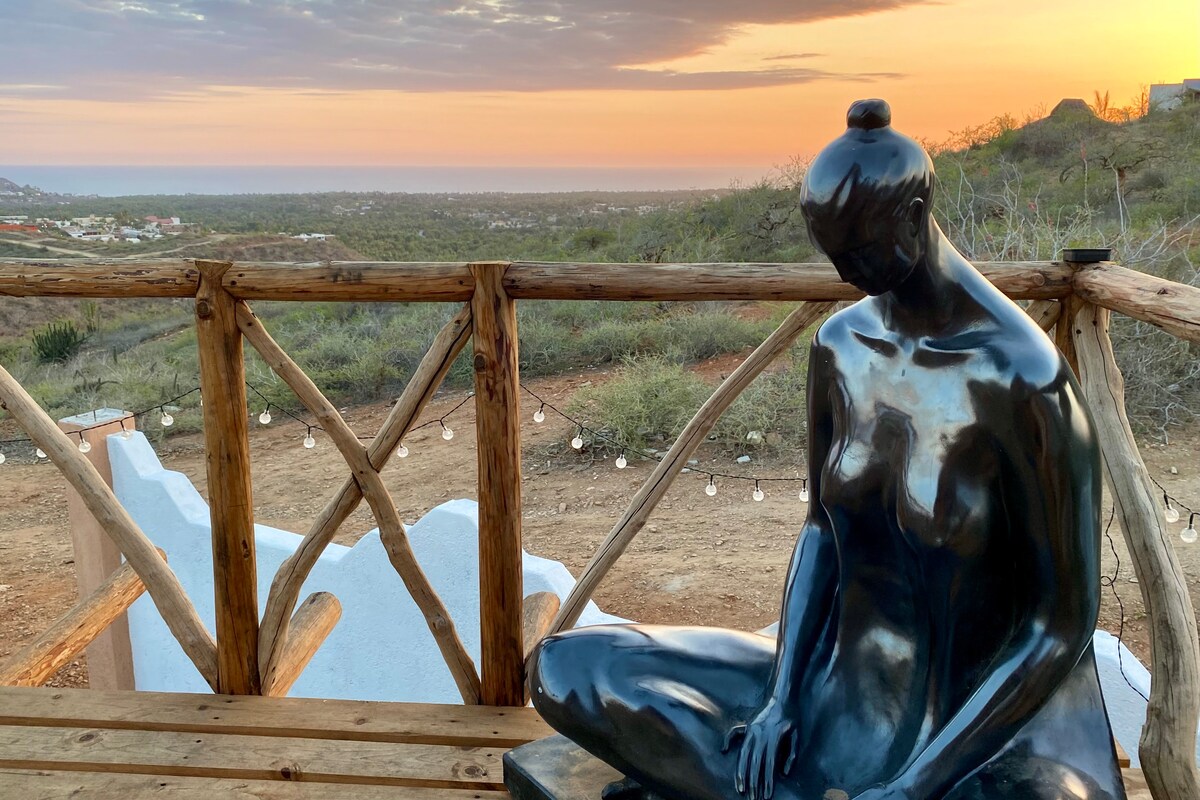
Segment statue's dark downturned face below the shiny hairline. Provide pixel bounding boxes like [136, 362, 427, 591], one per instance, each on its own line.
[805, 198, 925, 296]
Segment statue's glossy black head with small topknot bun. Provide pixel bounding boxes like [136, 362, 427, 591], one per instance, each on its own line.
[800, 100, 934, 295]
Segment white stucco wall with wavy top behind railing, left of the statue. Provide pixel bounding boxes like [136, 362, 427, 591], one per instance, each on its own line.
[108, 433, 625, 703]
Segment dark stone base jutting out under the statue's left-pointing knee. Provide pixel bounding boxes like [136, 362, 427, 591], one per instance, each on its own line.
[504, 736, 623, 800]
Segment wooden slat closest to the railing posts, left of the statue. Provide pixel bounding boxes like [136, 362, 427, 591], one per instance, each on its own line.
[0, 686, 553, 748]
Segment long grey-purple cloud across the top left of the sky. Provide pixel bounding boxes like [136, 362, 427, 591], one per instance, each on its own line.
[0, 0, 924, 100]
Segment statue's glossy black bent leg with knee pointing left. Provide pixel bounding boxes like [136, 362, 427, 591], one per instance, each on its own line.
[529, 625, 785, 800]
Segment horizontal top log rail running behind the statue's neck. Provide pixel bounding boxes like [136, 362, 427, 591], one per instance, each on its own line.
[0, 259, 1074, 302]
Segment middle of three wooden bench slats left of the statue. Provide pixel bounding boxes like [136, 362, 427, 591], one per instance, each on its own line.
[0, 726, 505, 789]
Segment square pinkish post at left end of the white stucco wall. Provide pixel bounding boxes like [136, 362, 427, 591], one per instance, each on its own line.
[59, 408, 138, 690]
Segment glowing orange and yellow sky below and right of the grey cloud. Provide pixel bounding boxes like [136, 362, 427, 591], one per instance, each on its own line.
[0, 0, 1200, 173]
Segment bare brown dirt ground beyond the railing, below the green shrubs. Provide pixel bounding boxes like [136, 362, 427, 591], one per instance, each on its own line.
[0, 369, 1200, 686]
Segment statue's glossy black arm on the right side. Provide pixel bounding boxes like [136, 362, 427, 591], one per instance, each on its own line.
[894, 376, 1100, 798]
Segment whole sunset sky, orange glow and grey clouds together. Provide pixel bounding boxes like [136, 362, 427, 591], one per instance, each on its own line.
[0, 0, 1200, 170]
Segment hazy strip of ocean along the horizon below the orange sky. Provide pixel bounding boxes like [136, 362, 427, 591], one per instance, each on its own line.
[0, 164, 770, 197]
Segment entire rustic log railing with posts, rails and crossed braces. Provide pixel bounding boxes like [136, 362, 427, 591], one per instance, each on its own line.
[0, 260, 1200, 799]
